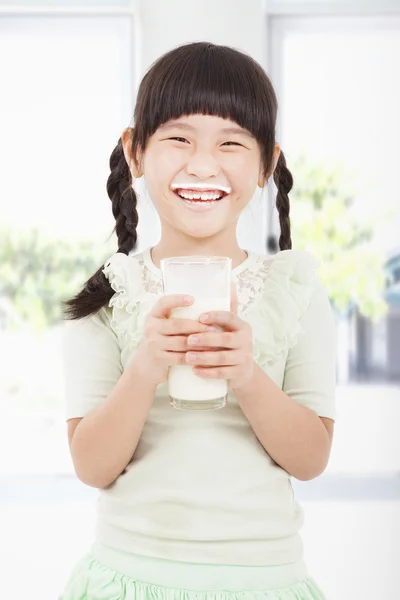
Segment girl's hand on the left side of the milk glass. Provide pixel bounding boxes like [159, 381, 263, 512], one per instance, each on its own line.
[134, 294, 215, 385]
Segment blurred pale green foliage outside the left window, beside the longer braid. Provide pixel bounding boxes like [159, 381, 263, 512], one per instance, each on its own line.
[0, 228, 116, 332]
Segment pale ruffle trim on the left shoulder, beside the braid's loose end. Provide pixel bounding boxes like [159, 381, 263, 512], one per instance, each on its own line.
[102, 252, 160, 347]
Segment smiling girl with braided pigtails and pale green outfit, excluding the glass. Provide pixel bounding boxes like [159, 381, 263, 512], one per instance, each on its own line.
[59, 42, 335, 600]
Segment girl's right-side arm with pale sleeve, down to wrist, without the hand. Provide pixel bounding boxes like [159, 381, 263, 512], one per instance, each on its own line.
[231, 282, 336, 481]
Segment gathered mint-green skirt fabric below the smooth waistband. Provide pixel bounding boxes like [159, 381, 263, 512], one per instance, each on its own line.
[58, 554, 325, 600]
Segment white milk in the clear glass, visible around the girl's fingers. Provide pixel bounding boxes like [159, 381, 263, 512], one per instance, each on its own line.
[168, 297, 230, 401]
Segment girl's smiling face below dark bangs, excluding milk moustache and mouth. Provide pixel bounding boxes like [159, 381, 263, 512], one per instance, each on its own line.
[124, 114, 276, 240]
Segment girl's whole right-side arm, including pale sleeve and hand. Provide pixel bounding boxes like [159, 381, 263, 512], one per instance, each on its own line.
[188, 283, 336, 480]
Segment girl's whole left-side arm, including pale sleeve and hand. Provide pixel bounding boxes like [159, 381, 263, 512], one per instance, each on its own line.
[63, 295, 208, 488]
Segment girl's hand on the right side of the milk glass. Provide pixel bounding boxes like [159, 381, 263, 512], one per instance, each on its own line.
[186, 289, 255, 389]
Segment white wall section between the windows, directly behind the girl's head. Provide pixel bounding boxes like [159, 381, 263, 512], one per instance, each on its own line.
[135, 0, 268, 252]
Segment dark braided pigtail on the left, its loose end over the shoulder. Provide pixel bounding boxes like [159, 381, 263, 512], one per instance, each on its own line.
[62, 138, 138, 320]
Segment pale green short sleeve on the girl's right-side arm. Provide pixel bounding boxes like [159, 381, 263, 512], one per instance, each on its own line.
[282, 278, 336, 420]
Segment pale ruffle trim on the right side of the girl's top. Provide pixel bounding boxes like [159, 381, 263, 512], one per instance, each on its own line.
[246, 250, 319, 367]
